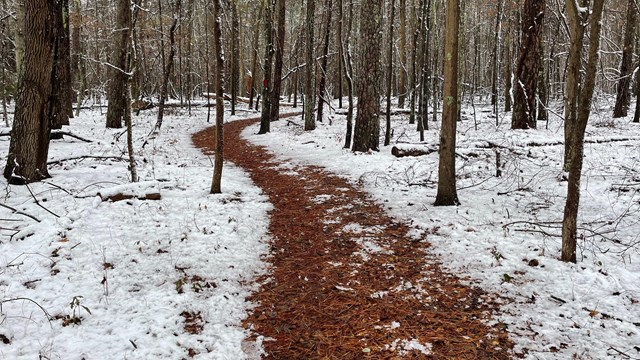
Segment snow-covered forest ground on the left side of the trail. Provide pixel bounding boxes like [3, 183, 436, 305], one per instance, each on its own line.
[0, 102, 271, 360]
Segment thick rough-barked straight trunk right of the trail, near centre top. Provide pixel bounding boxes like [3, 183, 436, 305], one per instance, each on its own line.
[353, 0, 383, 152]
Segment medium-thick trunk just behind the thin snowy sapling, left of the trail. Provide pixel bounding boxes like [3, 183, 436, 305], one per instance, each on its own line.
[107, 0, 131, 129]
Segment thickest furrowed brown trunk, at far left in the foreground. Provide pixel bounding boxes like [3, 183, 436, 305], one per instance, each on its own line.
[4, 0, 60, 184]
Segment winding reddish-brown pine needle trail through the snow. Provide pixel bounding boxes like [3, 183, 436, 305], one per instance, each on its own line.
[194, 119, 512, 360]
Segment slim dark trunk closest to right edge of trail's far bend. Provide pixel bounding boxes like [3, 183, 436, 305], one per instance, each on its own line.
[258, 0, 275, 134]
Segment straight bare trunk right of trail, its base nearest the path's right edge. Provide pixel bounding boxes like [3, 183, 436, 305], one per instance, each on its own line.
[435, 0, 460, 206]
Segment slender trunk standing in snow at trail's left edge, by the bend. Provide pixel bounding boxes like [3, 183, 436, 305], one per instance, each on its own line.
[211, 0, 224, 194]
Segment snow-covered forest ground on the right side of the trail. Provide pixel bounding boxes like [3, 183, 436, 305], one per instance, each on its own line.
[244, 99, 640, 359]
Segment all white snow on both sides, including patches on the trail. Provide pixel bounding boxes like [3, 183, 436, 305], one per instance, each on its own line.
[0, 94, 640, 360]
